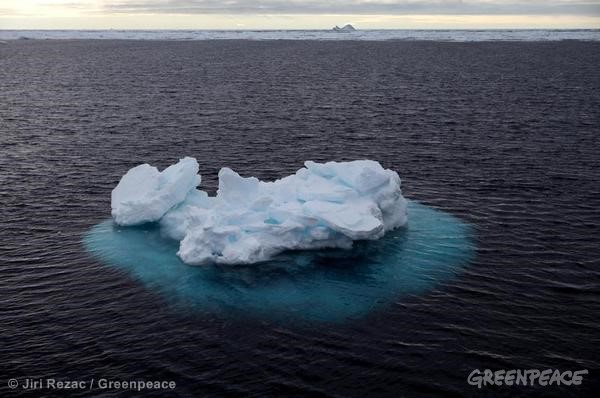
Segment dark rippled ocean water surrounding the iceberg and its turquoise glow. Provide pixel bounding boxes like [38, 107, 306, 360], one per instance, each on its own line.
[0, 41, 600, 397]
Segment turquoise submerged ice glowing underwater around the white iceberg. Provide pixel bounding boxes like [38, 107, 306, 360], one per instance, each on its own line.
[83, 201, 475, 321]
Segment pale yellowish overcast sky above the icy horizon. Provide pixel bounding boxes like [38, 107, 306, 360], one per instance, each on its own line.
[0, 0, 600, 29]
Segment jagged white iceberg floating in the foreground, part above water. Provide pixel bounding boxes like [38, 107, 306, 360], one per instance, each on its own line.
[111, 157, 407, 265]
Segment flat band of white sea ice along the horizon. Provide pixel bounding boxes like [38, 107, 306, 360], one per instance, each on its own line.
[0, 29, 600, 42]
